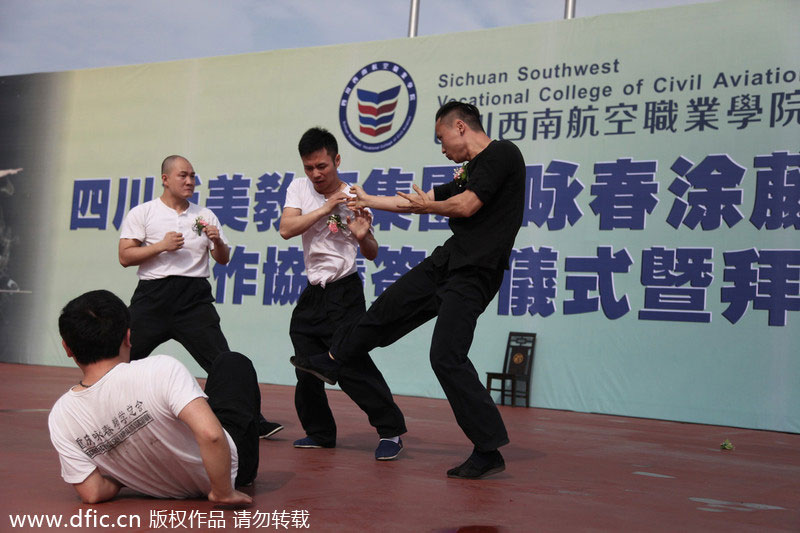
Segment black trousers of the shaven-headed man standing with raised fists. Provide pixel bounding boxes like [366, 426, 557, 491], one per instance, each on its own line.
[130, 276, 229, 373]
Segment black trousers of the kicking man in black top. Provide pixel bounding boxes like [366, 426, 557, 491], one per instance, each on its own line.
[331, 248, 508, 451]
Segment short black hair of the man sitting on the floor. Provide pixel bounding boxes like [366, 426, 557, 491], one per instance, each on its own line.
[58, 290, 131, 365]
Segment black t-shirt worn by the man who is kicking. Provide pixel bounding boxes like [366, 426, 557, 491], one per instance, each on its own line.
[433, 141, 525, 269]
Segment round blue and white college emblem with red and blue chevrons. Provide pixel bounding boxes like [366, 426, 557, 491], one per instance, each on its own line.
[339, 61, 417, 152]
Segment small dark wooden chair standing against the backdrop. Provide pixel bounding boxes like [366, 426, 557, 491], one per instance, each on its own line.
[486, 331, 536, 407]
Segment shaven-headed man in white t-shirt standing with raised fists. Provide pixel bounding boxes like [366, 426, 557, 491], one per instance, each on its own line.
[119, 155, 283, 437]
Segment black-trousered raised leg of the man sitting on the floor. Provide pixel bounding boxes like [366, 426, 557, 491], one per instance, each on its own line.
[205, 352, 261, 485]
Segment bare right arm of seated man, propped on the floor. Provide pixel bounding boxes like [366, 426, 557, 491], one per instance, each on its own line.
[178, 398, 253, 505]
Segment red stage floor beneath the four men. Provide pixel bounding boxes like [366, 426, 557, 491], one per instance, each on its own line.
[0, 364, 800, 532]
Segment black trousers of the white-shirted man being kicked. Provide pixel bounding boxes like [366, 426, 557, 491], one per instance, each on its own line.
[289, 274, 406, 446]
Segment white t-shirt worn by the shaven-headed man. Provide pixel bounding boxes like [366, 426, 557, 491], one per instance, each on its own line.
[119, 198, 228, 279]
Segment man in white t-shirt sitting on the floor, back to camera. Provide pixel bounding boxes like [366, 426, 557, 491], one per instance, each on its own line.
[48, 290, 261, 504]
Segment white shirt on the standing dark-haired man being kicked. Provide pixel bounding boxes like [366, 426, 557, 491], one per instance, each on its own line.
[284, 178, 372, 287]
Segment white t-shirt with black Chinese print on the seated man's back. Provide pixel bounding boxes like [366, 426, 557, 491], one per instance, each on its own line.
[48, 355, 238, 498]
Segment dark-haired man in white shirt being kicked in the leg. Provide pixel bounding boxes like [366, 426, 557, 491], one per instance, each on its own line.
[280, 128, 406, 461]
